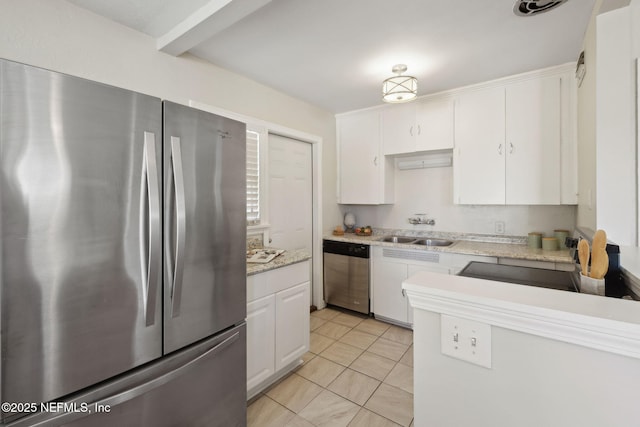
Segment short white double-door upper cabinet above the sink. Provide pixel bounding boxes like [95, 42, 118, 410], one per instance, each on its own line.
[381, 99, 454, 155]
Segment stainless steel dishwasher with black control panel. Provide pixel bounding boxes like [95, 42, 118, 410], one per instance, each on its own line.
[322, 240, 369, 314]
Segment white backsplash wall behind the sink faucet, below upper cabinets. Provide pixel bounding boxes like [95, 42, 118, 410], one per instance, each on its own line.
[340, 167, 576, 236]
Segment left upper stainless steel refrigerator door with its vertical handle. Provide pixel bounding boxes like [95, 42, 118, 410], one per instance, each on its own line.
[0, 60, 162, 419]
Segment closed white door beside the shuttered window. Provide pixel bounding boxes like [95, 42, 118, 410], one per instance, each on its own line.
[268, 134, 313, 254]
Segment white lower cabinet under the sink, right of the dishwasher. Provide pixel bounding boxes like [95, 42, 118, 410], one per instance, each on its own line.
[371, 246, 497, 326]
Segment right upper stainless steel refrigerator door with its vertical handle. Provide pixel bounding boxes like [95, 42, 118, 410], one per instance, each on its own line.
[163, 101, 247, 353]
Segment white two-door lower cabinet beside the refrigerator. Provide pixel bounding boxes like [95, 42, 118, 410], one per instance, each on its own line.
[247, 261, 311, 398]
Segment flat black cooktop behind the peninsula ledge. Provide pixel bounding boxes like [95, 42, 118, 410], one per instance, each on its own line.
[458, 261, 578, 292]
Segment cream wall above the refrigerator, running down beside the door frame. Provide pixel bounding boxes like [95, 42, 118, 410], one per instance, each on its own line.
[0, 0, 340, 234]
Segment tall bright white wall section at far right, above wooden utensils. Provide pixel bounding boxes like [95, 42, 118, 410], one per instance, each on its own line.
[596, 6, 640, 246]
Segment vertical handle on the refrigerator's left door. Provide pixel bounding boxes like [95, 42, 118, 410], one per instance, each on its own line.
[140, 132, 162, 326]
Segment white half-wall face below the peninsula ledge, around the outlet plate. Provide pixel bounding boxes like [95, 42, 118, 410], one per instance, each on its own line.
[414, 310, 640, 427]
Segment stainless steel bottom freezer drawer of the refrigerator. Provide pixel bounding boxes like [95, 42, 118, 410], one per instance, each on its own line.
[6, 323, 247, 427]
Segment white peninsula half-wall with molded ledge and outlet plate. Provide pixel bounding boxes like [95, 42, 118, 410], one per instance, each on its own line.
[403, 272, 640, 427]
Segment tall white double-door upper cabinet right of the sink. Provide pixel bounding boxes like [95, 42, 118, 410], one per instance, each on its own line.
[454, 66, 577, 205]
